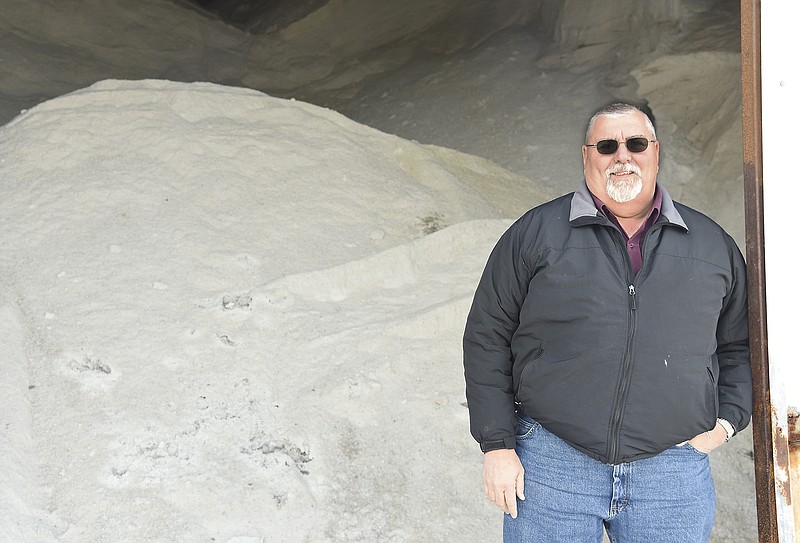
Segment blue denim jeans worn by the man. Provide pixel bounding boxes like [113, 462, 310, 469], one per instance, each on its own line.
[503, 415, 716, 543]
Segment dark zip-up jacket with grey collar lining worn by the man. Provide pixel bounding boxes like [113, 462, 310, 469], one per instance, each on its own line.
[464, 185, 752, 464]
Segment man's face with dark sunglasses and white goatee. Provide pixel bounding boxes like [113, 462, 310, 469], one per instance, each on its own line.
[583, 112, 658, 213]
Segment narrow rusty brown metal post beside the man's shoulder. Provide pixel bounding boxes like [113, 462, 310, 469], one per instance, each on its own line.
[741, 0, 778, 543]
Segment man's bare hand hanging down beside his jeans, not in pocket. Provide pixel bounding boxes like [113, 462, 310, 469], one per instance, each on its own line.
[483, 448, 524, 518]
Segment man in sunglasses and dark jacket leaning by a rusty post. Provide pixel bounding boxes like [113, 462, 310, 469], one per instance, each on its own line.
[464, 104, 752, 543]
